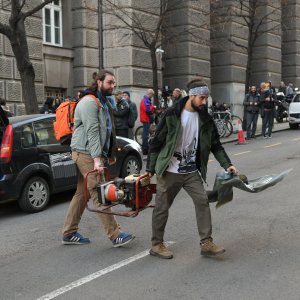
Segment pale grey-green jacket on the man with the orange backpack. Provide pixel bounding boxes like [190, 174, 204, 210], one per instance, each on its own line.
[71, 96, 116, 158]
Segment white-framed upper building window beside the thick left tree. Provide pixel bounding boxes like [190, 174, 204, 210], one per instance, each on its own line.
[43, 0, 62, 46]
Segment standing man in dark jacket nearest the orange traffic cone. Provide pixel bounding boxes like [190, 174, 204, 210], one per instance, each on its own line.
[243, 85, 260, 140]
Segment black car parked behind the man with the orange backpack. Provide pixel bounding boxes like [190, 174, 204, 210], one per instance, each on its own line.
[0, 114, 142, 213]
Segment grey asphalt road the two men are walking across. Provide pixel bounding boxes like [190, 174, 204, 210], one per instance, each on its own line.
[0, 130, 300, 300]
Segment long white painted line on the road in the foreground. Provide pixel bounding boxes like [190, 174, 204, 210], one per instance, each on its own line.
[37, 241, 175, 300]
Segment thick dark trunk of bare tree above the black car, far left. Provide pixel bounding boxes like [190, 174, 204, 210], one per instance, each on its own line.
[0, 0, 52, 114]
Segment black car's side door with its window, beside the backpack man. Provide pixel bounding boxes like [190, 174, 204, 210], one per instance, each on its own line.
[33, 116, 77, 192]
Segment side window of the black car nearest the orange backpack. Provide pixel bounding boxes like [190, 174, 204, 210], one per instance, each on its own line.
[33, 119, 58, 145]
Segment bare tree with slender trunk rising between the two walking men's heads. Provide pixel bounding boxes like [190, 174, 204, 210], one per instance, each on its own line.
[102, 0, 204, 105]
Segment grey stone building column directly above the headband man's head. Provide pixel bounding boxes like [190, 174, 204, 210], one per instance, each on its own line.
[163, 0, 211, 90]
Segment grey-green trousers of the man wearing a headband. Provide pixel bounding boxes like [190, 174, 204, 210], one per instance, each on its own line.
[151, 172, 212, 245]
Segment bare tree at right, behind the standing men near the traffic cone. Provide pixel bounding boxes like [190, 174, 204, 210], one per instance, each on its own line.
[211, 0, 287, 92]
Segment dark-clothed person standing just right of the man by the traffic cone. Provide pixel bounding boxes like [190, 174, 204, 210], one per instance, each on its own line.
[260, 89, 278, 139]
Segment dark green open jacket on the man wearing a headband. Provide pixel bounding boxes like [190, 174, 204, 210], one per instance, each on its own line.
[146, 97, 232, 180]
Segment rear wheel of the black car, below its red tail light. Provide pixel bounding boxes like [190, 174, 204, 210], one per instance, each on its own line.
[18, 176, 50, 213]
